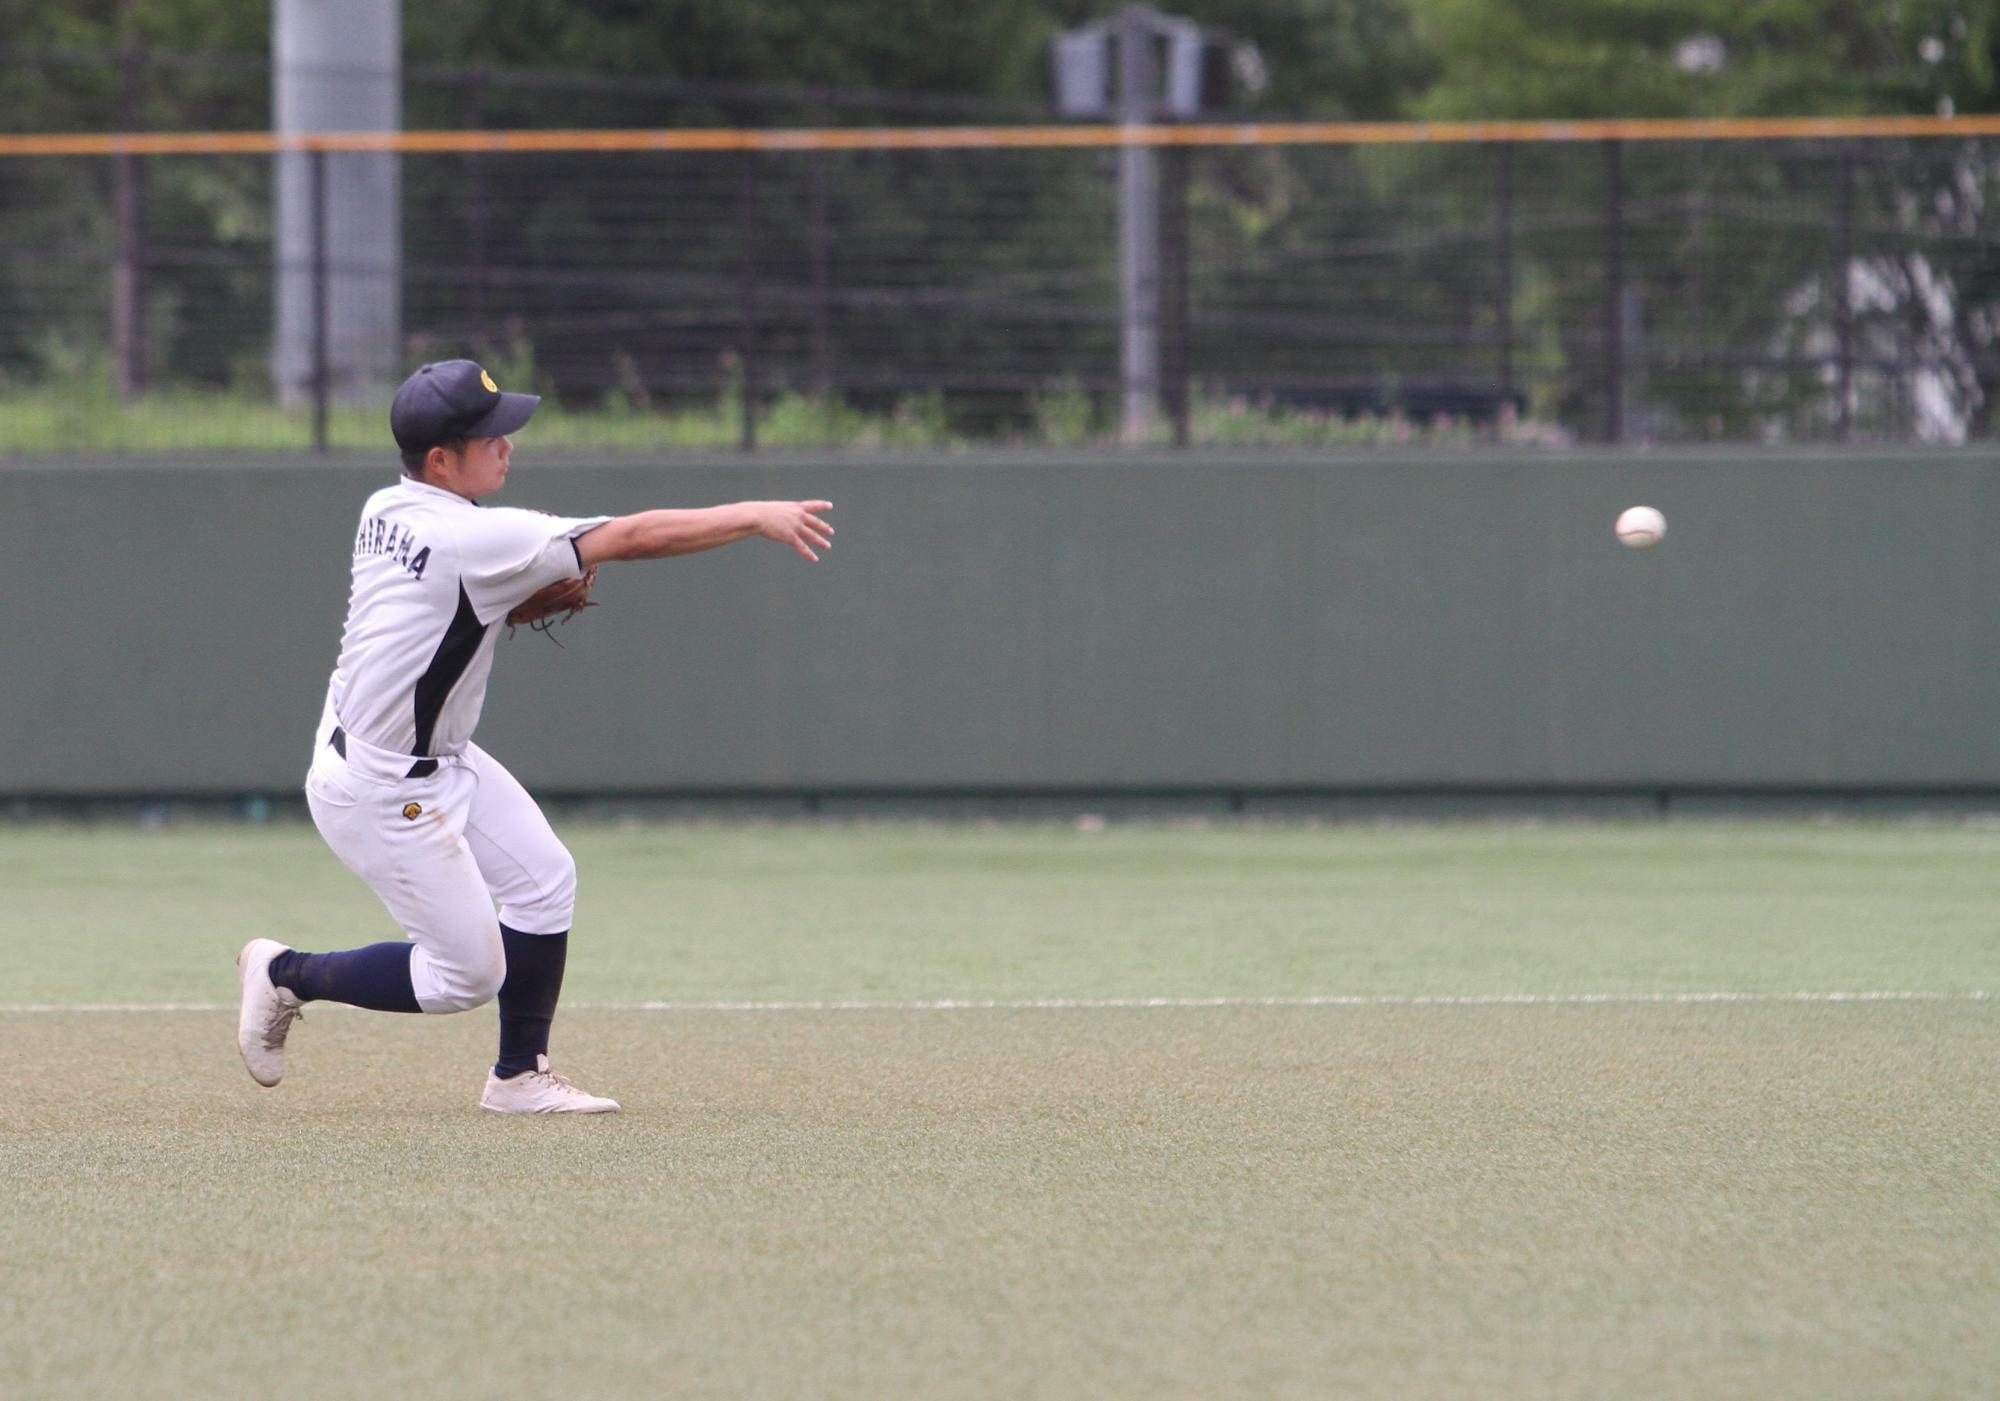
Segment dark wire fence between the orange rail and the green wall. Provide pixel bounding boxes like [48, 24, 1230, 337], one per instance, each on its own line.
[0, 49, 2000, 454]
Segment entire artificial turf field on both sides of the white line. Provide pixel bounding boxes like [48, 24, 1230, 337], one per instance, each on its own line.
[0, 825, 2000, 1397]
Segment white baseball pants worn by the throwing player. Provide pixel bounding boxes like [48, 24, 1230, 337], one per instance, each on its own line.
[306, 727, 576, 1013]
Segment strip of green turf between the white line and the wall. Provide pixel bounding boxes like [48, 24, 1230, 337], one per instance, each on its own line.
[11, 823, 2000, 1005]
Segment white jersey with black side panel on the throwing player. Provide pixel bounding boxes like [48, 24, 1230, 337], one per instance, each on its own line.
[320, 476, 610, 757]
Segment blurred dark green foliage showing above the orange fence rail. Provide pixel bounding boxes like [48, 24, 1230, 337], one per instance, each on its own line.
[0, 0, 2000, 130]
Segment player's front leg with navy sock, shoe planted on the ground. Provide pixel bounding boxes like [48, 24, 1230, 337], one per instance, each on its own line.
[464, 745, 618, 1113]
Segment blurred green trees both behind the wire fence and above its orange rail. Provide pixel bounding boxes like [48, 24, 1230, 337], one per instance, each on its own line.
[0, 0, 2000, 438]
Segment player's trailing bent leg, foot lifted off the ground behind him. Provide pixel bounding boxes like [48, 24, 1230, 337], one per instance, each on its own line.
[238, 741, 506, 1085]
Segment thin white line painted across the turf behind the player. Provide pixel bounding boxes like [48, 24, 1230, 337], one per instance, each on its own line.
[0, 991, 1992, 1015]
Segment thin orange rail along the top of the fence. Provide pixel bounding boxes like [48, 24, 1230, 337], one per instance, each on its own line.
[0, 116, 2000, 156]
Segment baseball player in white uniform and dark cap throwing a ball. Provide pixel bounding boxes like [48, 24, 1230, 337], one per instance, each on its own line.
[236, 360, 834, 1113]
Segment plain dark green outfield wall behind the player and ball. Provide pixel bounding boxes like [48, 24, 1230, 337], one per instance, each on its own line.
[0, 444, 2000, 797]
